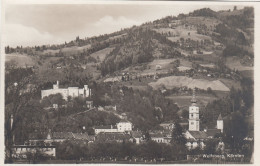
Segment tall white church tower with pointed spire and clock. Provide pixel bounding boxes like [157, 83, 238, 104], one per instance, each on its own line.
[189, 89, 200, 131]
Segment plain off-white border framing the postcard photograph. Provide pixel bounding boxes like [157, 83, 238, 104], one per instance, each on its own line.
[0, 0, 260, 165]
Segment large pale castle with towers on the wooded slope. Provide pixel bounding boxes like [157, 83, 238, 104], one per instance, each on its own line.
[41, 81, 91, 100]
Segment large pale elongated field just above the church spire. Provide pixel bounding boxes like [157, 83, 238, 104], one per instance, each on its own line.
[149, 76, 229, 91]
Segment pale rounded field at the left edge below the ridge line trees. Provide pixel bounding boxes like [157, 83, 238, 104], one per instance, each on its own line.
[5, 53, 35, 67]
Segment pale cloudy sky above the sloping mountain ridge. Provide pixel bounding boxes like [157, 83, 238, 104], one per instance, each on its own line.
[4, 4, 242, 47]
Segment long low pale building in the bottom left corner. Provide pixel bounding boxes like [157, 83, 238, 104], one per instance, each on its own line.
[12, 145, 56, 159]
